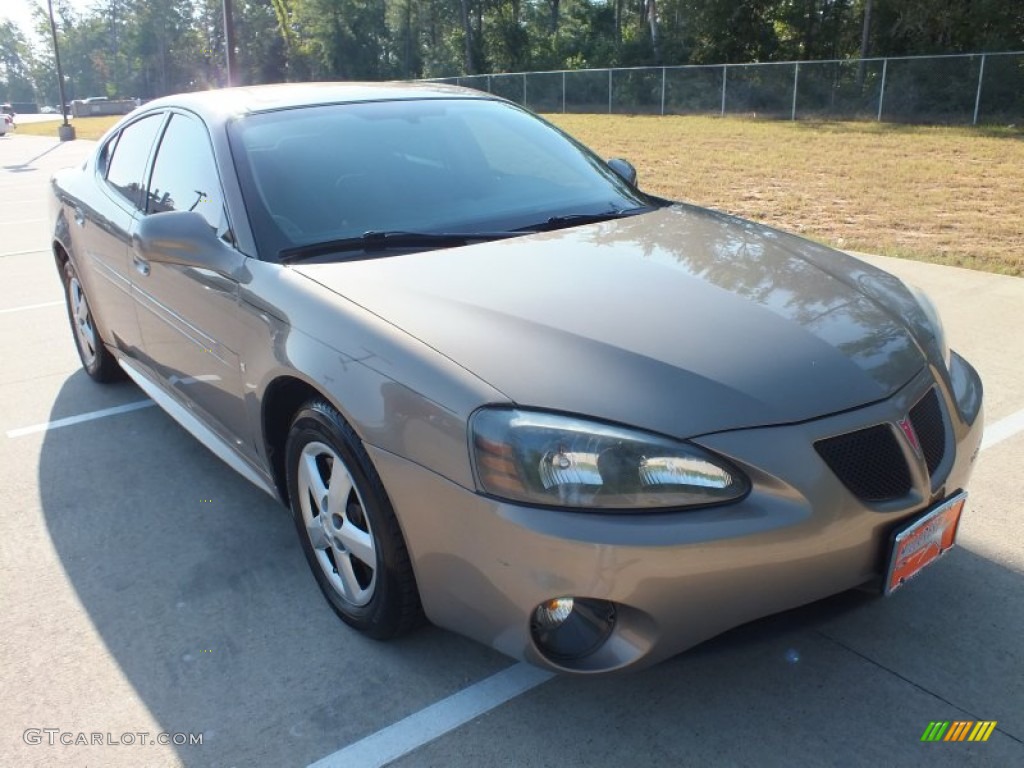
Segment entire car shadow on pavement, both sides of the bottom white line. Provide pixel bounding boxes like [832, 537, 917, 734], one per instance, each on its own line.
[39, 376, 1024, 766]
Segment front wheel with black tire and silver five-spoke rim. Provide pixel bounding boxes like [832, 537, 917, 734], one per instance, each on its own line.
[285, 398, 423, 640]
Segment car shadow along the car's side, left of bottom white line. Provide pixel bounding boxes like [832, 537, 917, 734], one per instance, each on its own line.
[39, 375, 510, 766]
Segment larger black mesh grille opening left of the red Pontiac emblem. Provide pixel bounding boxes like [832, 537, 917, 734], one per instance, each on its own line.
[814, 424, 916, 502]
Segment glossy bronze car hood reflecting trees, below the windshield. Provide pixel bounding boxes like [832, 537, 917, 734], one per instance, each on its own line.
[295, 205, 925, 437]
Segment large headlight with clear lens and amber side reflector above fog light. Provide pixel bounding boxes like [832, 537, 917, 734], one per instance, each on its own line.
[470, 408, 750, 511]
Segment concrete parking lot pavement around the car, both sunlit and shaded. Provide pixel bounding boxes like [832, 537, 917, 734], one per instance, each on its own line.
[0, 136, 1024, 768]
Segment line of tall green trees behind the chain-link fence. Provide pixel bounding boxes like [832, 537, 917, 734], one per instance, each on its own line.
[0, 0, 1024, 104]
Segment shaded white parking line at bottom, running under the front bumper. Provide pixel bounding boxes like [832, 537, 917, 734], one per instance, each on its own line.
[309, 663, 554, 768]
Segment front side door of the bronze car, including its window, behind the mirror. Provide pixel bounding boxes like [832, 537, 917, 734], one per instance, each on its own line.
[132, 111, 253, 456]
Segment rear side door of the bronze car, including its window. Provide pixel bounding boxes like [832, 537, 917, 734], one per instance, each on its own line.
[69, 112, 166, 356]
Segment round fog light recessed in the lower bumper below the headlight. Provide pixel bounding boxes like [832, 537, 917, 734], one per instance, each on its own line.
[529, 597, 615, 662]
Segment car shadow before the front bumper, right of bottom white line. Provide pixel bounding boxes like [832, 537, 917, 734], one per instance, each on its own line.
[417, 548, 1024, 768]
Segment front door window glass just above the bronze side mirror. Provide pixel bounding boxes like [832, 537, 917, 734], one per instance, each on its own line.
[148, 114, 225, 233]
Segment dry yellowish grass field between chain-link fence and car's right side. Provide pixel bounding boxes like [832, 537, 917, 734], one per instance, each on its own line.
[547, 115, 1024, 275]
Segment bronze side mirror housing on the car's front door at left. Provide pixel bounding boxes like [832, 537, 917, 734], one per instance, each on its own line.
[132, 211, 244, 279]
